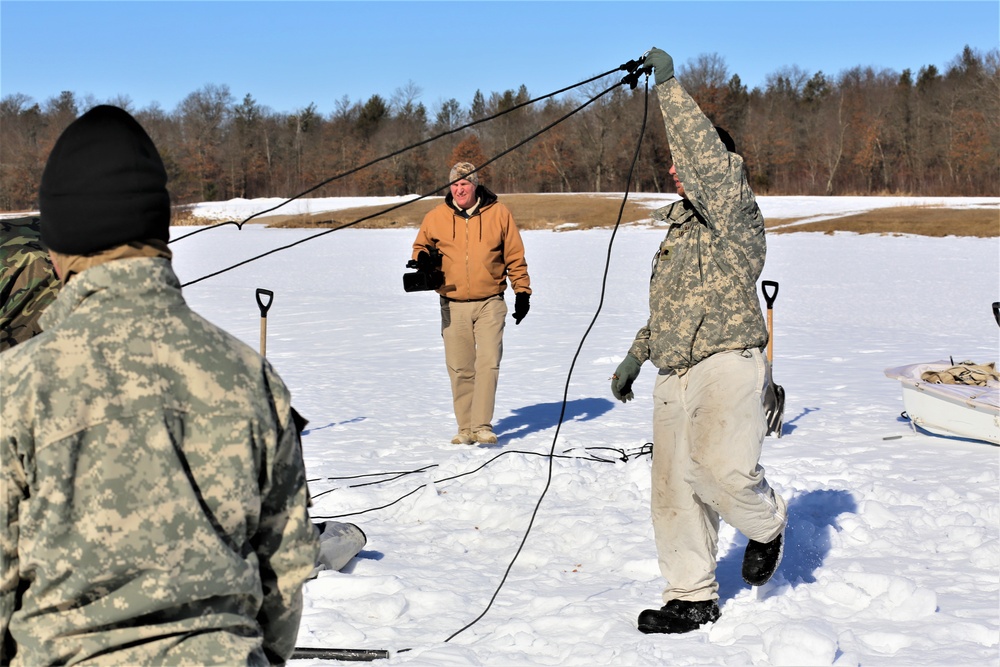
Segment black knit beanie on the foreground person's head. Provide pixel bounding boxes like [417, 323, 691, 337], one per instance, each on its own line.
[38, 105, 170, 255]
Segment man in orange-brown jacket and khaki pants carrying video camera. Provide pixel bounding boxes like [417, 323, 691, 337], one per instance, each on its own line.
[413, 162, 531, 445]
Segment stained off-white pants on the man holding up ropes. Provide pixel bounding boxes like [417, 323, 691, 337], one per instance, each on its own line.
[651, 349, 787, 603]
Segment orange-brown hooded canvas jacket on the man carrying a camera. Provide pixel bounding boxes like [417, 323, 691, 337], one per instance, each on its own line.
[413, 185, 531, 301]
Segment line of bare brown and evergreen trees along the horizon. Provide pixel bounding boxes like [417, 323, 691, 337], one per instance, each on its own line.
[0, 46, 1000, 210]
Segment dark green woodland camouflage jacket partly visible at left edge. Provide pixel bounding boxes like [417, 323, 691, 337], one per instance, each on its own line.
[0, 217, 59, 352]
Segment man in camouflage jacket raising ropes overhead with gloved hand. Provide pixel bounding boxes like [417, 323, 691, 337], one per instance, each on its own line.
[612, 49, 786, 633]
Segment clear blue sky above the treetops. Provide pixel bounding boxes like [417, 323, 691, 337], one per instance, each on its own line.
[0, 0, 1000, 114]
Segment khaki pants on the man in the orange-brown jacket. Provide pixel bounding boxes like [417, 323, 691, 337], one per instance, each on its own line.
[441, 297, 507, 431]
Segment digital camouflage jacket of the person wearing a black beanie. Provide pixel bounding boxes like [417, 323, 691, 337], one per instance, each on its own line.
[0, 258, 318, 665]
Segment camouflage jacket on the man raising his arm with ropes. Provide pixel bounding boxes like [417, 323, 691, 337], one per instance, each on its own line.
[629, 79, 767, 370]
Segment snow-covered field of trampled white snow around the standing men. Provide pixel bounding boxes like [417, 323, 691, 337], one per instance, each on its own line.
[171, 197, 1000, 667]
